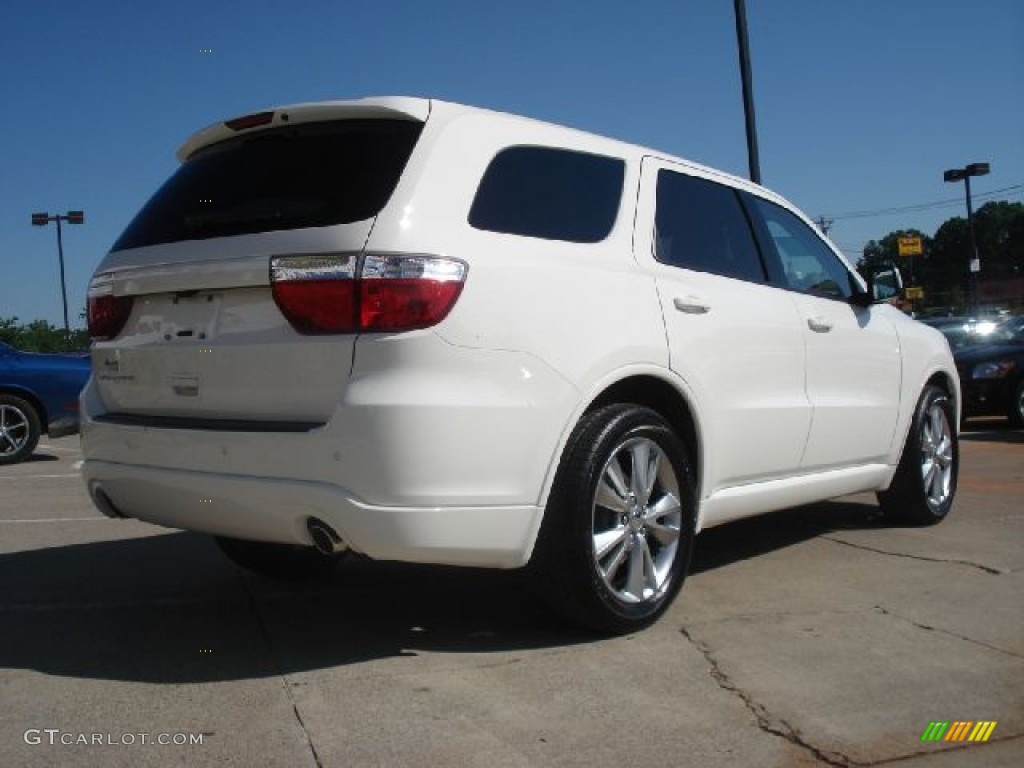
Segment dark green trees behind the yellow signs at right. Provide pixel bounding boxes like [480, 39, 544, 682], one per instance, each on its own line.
[860, 201, 1024, 312]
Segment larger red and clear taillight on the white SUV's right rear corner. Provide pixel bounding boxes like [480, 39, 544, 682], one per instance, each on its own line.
[270, 254, 466, 334]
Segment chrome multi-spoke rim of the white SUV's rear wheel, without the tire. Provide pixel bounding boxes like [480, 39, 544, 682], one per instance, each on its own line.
[591, 437, 683, 603]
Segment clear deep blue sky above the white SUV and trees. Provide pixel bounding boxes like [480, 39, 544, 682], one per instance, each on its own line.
[0, 0, 1024, 326]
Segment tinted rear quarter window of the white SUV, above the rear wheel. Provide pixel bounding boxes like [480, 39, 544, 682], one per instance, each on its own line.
[469, 146, 626, 243]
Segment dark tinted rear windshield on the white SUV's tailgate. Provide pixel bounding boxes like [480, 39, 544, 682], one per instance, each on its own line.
[113, 120, 423, 251]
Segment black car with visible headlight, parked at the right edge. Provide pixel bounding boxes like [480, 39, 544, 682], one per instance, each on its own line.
[953, 318, 1024, 427]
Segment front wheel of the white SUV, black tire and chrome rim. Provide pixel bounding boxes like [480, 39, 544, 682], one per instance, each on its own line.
[879, 385, 959, 525]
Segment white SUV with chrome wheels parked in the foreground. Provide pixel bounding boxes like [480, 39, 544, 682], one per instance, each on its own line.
[82, 98, 959, 632]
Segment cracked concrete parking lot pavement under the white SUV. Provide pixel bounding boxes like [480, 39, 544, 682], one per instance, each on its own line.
[0, 427, 1024, 768]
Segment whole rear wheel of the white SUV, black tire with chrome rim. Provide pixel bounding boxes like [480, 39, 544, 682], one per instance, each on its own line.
[530, 404, 696, 634]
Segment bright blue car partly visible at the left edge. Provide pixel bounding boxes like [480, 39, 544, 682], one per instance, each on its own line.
[0, 342, 89, 464]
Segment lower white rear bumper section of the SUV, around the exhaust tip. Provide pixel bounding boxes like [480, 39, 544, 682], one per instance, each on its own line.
[82, 461, 543, 568]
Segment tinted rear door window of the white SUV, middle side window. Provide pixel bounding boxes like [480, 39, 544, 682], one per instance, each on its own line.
[654, 171, 767, 283]
